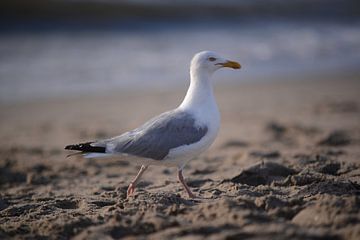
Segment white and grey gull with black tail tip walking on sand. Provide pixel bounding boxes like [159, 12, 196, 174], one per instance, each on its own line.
[65, 51, 241, 198]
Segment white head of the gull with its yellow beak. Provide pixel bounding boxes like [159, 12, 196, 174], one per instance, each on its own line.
[190, 51, 241, 78]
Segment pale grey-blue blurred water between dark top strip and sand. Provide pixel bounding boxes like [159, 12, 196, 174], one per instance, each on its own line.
[0, 19, 360, 102]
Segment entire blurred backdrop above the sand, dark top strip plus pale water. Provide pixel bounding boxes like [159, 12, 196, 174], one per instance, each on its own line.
[0, 0, 360, 102]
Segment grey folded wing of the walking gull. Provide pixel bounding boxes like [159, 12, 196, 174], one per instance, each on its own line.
[97, 110, 208, 160]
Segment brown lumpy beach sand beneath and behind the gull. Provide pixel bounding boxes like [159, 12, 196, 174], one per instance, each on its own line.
[0, 77, 360, 239]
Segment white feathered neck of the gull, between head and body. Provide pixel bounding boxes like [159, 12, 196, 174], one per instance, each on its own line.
[180, 71, 217, 110]
